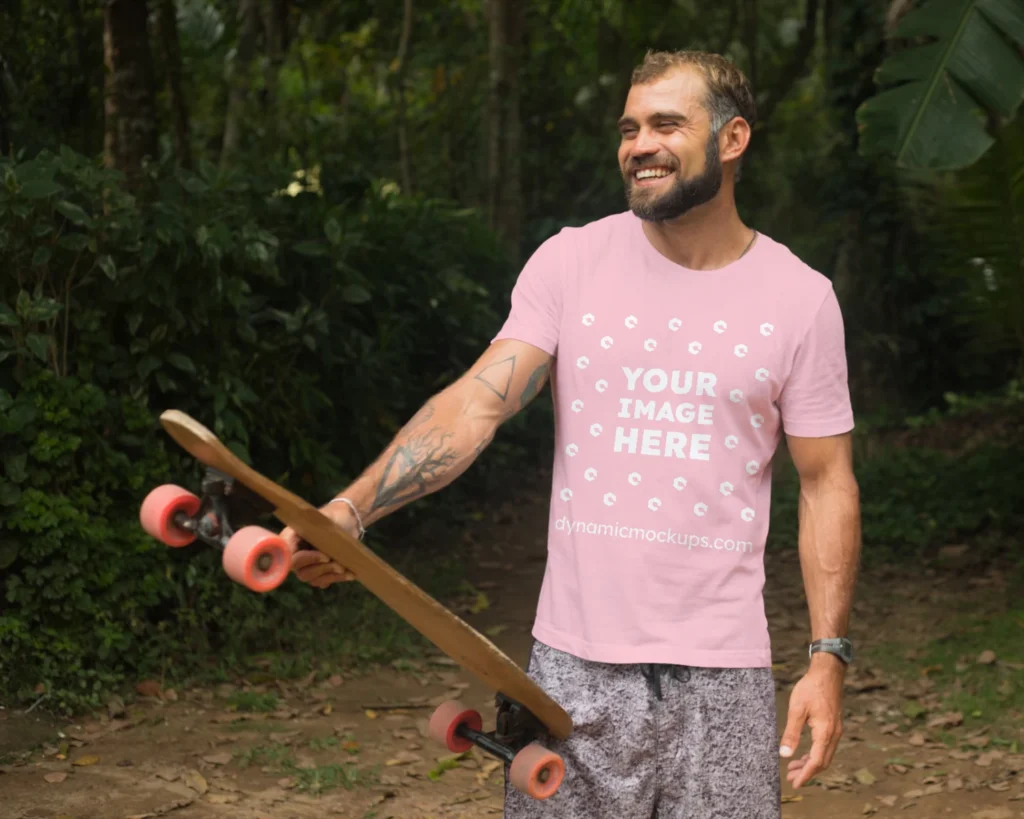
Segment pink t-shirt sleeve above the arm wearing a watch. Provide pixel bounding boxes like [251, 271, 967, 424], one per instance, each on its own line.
[779, 287, 854, 438]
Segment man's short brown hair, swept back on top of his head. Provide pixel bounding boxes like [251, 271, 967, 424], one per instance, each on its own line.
[632, 51, 758, 134]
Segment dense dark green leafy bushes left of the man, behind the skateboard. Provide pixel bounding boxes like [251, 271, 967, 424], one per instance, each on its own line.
[0, 149, 544, 708]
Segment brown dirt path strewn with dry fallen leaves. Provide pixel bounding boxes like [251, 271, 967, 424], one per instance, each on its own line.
[0, 493, 1024, 819]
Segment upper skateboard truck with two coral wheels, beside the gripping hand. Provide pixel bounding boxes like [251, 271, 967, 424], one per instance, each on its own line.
[139, 467, 292, 592]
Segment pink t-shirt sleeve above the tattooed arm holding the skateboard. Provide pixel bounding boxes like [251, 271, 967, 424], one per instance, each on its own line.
[493, 232, 567, 355]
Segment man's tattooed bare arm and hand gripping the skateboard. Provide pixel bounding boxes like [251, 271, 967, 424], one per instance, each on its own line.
[282, 339, 553, 587]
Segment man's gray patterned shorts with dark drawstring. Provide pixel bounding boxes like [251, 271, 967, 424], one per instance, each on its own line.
[505, 642, 781, 819]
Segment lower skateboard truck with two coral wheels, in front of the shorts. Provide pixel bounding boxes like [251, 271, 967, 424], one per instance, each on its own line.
[429, 694, 565, 800]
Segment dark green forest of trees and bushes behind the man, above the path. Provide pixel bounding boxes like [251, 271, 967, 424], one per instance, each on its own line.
[0, 0, 1024, 710]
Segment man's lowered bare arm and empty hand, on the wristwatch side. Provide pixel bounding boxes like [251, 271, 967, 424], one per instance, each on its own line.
[779, 433, 860, 787]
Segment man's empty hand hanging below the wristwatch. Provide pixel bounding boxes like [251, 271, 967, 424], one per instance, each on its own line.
[779, 654, 846, 788]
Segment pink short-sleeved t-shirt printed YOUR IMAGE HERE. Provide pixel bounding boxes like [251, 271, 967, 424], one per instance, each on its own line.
[496, 211, 853, 667]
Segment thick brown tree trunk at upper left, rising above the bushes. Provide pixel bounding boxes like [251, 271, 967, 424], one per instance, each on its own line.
[103, 0, 158, 186]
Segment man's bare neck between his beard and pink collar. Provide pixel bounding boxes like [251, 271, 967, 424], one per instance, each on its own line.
[643, 197, 755, 270]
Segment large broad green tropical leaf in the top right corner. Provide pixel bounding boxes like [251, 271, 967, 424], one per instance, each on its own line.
[857, 0, 1024, 170]
